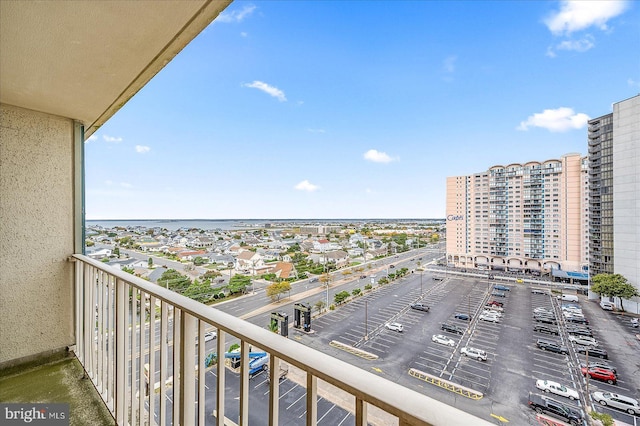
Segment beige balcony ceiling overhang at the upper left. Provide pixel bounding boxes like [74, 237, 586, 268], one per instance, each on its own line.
[0, 0, 232, 137]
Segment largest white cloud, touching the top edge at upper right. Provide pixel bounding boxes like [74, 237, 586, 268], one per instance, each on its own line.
[544, 0, 628, 35]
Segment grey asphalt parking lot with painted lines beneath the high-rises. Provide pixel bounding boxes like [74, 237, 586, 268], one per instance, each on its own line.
[296, 273, 640, 425]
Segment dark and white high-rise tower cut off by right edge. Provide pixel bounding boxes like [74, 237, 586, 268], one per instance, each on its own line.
[588, 95, 640, 311]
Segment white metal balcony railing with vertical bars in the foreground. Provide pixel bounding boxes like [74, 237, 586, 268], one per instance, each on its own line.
[72, 255, 491, 426]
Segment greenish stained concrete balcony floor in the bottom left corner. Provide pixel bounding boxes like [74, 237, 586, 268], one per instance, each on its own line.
[0, 355, 115, 426]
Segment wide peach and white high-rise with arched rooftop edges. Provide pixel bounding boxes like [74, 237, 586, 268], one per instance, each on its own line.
[447, 154, 589, 273]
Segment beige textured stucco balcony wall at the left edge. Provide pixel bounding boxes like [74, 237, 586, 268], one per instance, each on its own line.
[0, 105, 74, 367]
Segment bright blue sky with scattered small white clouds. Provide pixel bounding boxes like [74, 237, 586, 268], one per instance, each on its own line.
[85, 1, 640, 219]
